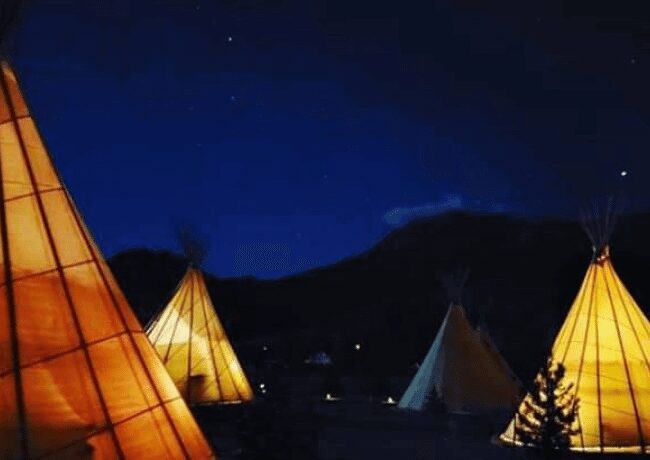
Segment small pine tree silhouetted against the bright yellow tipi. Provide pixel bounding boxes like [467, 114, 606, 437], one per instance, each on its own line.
[515, 357, 580, 456]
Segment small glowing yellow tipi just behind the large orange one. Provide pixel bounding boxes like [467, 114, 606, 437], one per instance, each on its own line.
[147, 266, 253, 404]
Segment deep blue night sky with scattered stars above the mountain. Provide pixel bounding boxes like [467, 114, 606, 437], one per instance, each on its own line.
[9, 0, 650, 277]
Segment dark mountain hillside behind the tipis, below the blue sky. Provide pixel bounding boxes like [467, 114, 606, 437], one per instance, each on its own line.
[110, 213, 650, 380]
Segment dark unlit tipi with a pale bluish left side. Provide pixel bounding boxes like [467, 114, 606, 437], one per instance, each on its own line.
[398, 303, 521, 412]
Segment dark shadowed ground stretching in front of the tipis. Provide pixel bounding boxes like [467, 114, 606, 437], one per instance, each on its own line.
[190, 402, 640, 460]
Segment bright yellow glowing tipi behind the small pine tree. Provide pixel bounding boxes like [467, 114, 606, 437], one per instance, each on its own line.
[501, 248, 650, 452]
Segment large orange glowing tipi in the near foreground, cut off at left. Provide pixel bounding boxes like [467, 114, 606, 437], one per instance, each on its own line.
[0, 63, 213, 459]
